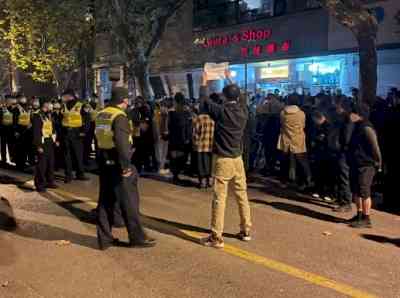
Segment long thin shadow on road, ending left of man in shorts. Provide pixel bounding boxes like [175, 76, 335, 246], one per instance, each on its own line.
[250, 199, 346, 223]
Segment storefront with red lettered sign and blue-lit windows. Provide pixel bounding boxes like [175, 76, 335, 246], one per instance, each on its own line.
[151, 1, 400, 98]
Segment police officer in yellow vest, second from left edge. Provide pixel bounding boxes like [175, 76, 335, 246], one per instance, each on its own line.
[15, 95, 32, 171]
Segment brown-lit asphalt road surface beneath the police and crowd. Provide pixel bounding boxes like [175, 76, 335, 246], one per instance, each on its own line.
[0, 171, 400, 298]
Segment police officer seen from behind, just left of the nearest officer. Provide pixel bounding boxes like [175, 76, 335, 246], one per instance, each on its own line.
[61, 90, 88, 183]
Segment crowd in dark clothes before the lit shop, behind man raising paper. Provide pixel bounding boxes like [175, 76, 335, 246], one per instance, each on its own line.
[126, 89, 400, 219]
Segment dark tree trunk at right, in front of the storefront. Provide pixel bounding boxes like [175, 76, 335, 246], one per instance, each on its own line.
[356, 25, 378, 106]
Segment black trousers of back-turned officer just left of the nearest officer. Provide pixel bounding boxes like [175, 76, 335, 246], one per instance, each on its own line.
[62, 132, 85, 179]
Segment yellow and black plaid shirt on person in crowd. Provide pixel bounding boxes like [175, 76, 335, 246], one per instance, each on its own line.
[192, 114, 215, 152]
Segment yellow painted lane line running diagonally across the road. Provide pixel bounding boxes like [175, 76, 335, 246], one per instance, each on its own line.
[53, 189, 378, 298]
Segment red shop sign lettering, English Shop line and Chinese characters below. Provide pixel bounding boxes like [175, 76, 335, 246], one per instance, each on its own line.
[194, 29, 292, 58]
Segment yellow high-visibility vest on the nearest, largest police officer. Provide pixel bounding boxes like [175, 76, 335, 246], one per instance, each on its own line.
[95, 107, 127, 150]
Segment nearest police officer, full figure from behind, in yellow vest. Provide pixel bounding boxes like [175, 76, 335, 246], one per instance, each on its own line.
[95, 89, 156, 250]
